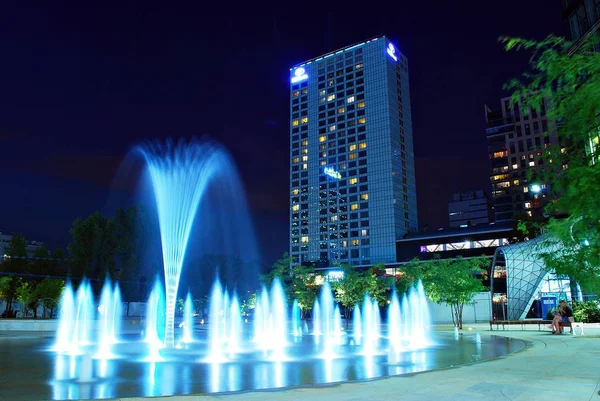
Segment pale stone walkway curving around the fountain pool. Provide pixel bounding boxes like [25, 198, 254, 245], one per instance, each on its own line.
[119, 324, 600, 401]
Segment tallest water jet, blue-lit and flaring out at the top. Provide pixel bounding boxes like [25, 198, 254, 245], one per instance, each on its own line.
[139, 142, 222, 346]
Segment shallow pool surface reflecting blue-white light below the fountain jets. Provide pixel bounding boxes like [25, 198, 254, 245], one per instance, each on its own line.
[0, 333, 525, 400]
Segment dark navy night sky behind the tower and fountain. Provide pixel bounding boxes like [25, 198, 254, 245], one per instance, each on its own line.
[0, 0, 564, 263]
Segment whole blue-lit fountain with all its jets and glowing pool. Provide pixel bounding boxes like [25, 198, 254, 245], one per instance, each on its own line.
[10, 137, 514, 399]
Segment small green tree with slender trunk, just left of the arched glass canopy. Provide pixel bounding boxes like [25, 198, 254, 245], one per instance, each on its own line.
[406, 256, 490, 329]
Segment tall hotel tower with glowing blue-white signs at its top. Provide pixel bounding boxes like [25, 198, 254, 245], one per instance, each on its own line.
[290, 36, 417, 266]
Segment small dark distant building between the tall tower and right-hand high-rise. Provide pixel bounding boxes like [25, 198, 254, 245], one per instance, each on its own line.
[448, 191, 493, 227]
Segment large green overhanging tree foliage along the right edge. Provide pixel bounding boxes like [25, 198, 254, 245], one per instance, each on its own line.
[500, 36, 600, 290]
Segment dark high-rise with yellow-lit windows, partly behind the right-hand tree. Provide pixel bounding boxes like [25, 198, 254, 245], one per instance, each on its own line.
[485, 97, 558, 223]
